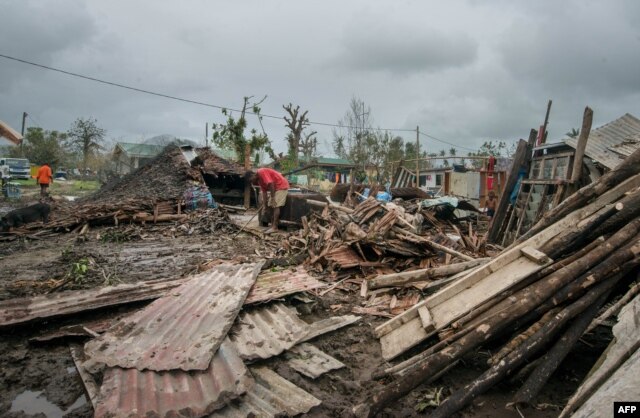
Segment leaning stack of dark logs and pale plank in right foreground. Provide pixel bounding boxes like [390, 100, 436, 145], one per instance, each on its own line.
[356, 145, 640, 417]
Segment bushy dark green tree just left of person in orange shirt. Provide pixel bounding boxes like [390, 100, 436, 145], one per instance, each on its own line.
[10, 127, 69, 166]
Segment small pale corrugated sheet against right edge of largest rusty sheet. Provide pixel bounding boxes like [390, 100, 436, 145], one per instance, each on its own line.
[229, 303, 308, 360]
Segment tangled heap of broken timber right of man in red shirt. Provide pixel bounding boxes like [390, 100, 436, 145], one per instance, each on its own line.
[283, 198, 480, 273]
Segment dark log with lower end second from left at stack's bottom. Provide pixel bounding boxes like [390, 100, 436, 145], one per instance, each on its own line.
[431, 282, 613, 418]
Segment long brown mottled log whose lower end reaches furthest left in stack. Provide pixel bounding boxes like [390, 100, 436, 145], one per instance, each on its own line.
[359, 224, 640, 416]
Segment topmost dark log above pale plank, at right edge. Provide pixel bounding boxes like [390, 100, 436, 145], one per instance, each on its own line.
[516, 149, 640, 243]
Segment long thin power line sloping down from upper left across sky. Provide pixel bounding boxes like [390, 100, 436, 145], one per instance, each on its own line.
[0, 54, 414, 132]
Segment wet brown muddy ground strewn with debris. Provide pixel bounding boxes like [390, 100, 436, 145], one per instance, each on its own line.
[0, 201, 609, 418]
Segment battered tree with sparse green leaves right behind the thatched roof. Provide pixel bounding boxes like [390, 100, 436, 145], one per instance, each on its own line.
[212, 96, 276, 164]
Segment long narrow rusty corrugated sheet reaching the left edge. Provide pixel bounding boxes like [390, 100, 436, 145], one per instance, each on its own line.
[0, 279, 187, 327]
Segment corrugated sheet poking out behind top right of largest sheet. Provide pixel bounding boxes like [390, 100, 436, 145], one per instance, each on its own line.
[245, 268, 325, 304]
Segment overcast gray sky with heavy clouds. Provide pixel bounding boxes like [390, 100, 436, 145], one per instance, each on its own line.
[0, 0, 640, 155]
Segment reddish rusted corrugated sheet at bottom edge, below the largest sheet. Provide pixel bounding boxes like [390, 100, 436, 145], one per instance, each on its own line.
[95, 340, 253, 418]
